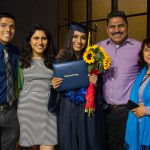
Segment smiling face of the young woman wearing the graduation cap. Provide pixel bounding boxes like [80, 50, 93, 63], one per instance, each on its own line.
[72, 31, 86, 52]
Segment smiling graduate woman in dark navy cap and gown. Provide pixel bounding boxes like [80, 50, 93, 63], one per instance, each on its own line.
[48, 24, 105, 150]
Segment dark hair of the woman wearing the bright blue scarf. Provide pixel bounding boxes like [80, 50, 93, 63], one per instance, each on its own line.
[138, 37, 150, 69]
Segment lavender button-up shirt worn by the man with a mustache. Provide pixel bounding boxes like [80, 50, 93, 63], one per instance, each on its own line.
[98, 38, 141, 105]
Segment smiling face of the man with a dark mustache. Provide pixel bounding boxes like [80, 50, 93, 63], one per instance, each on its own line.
[107, 17, 128, 45]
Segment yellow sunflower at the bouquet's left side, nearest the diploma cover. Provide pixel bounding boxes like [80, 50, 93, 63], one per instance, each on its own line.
[83, 50, 95, 64]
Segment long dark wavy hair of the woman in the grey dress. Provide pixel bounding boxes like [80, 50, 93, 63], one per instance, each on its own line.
[20, 24, 55, 68]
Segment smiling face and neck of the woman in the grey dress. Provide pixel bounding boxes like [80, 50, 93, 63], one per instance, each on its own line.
[30, 30, 48, 58]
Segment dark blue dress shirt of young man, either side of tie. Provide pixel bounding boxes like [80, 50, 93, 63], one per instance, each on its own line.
[0, 43, 18, 104]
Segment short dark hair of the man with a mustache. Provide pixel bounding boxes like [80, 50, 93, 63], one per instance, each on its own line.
[106, 11, 128, 25]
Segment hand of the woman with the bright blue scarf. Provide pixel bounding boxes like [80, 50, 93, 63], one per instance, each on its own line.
[131, 104, 146, 118]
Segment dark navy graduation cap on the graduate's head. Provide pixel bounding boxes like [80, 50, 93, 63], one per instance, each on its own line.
[63, 18, 97, 33]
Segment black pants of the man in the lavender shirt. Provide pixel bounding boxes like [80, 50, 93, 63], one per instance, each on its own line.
[105, 108, 128, 150]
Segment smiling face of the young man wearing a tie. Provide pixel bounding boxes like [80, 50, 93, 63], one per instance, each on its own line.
[0, 17, 15, 45]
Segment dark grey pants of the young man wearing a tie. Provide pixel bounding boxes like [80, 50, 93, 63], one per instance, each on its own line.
[0, 105, 19, 150]
